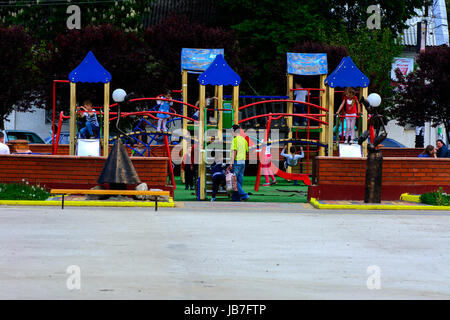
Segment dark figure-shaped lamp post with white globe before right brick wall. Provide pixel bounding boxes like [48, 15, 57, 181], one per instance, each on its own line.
[358, 93, 387, 203]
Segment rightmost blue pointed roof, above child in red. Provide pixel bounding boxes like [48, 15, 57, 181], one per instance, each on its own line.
[325, 57, 370, 88]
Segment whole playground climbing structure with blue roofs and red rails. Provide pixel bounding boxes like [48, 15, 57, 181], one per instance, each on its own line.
[48, 49, 376, 200]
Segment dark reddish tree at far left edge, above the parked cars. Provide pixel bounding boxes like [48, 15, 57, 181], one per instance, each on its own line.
[0, 27, 36, 129]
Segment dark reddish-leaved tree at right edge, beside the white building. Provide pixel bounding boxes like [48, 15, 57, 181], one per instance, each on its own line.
[391, 45, 450, 138]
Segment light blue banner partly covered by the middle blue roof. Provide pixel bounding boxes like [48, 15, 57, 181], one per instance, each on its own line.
[181, 48, 224, 71]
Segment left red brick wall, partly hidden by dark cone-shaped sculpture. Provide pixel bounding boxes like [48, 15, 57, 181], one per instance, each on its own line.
[0, 154, 171, 196]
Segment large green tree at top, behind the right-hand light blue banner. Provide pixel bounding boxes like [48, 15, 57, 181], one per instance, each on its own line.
[218, 0, 423, 93]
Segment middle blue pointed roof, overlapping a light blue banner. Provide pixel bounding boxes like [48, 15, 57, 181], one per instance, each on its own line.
[198, 54, 241, 87]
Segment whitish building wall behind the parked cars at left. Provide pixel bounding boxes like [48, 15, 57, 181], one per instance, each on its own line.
[5, 107, 69, 139]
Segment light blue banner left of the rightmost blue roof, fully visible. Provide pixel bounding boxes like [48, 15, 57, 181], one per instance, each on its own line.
[286, 52, 328, 76]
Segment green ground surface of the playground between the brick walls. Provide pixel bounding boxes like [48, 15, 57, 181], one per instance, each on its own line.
[175, 176, 308, 203]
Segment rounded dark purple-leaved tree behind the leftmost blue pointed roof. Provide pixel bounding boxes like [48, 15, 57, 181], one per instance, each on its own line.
[34, 25, 157, 114]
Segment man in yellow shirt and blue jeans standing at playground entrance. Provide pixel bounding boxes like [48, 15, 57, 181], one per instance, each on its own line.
[230, 124, 249, 201]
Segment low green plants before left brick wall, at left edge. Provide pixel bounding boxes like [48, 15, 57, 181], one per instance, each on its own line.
[0, 181, 50, 200]
